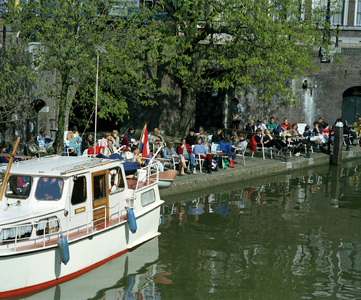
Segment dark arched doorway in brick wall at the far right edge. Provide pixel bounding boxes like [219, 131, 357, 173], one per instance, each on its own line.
[342, 86, 361, 125]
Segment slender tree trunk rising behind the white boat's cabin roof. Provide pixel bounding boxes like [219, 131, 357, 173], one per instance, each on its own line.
[55, 78, 69, 155]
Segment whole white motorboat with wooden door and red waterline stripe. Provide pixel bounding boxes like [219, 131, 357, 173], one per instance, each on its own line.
[0, 156, 163, 298]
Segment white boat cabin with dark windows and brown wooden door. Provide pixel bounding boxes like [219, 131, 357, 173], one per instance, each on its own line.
[0, 156, 160, 250]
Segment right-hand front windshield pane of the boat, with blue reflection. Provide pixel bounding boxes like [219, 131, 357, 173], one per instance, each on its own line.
[35, 177, 64, 201]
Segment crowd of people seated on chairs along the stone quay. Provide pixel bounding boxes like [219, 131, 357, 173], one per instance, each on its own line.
[0, 110, 361, 175]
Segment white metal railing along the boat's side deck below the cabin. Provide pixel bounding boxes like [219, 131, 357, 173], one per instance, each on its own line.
[0, 203, 126, 253]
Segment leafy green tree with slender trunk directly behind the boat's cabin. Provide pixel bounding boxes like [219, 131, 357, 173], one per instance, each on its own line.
[13, 0, 160, 154]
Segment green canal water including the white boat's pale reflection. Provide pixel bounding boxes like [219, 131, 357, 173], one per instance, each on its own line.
[27, 161, 361, 299]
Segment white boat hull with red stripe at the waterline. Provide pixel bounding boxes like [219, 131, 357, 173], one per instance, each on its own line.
[0, 202, 161, 298]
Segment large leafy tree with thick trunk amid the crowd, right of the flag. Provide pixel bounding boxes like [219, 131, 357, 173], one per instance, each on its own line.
[155, 0, 338, 135]
